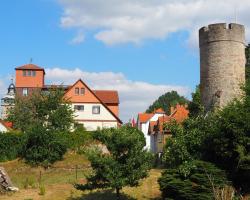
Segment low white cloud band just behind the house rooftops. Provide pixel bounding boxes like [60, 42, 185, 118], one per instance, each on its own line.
[46, 68, 190, 122]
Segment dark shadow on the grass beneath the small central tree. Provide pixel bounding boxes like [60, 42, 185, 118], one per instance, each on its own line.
[67, 190, 136, 200]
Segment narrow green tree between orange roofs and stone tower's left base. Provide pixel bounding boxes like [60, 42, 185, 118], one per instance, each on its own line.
[188, 85, 204, 117]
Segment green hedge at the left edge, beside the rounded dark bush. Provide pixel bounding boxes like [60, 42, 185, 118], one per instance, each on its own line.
[0, 132, 24, 162]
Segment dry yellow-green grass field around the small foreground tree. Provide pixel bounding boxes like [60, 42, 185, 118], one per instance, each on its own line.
[0, 153, 161, 200]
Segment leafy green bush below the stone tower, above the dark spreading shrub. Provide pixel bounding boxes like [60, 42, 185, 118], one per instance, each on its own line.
[162, 114, 216, 168]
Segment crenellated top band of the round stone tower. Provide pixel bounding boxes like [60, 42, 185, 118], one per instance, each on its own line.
[199, 23, 245, 46]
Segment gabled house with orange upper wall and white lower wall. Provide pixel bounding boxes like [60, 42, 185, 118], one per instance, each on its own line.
[64, 79, 122, 131]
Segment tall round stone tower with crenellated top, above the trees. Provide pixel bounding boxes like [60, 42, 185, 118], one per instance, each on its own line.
[199, 23, 246, 111]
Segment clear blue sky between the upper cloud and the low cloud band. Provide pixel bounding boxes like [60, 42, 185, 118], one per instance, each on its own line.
[0, 0, 199, 87]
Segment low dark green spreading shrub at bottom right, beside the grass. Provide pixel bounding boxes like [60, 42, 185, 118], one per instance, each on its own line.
[159, 160, 229, 200]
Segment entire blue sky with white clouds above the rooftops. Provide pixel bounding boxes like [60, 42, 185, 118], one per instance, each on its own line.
[0, 0, 250, 120]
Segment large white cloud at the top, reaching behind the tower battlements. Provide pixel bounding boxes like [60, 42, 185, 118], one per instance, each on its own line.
[59, 0, 250, 45]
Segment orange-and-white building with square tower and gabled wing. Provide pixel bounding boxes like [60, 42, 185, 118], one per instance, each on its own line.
[2, 64, 122, 131]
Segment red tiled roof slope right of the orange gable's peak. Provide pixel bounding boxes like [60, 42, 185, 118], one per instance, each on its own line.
[92, 90, 119, 104]
